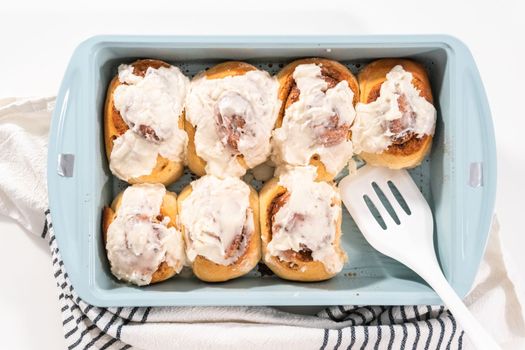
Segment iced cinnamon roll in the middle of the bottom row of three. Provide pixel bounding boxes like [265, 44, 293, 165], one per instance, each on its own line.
[178, 175, 261, 282]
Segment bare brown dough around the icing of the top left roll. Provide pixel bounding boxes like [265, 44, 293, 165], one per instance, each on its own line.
[104, 59, 184, 186]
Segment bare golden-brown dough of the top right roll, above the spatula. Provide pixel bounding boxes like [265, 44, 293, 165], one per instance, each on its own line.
[357, 58, 433, 169]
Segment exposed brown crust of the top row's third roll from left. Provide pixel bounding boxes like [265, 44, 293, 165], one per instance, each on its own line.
[274, 58, 359, 181]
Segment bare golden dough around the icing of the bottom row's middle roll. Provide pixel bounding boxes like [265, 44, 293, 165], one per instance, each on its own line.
[177, 180, 261, 282]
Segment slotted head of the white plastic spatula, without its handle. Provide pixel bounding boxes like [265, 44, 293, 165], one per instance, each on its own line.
[339, 165, 436, 272]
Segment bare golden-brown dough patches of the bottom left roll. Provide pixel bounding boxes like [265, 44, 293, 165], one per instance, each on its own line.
[102, 187, 181, 284]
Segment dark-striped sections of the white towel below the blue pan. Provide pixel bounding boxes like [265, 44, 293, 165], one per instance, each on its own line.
[41, 210, 463, 350]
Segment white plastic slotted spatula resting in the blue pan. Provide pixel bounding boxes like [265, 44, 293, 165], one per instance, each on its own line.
[339, 165, 499, 349]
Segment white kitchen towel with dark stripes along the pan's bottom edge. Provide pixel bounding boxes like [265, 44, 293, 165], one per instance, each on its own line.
[42, 210, 463, 350]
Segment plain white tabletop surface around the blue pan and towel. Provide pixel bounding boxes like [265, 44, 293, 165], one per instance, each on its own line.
[0, 0, 525, 349]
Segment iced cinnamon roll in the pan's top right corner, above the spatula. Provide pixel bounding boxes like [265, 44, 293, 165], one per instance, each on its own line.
[352, 59, 436, 169]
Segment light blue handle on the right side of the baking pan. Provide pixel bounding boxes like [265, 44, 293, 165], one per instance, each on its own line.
[456, 41, 496, 294]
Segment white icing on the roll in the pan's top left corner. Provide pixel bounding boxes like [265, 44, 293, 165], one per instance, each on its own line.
[110, 64, 189, 180]
